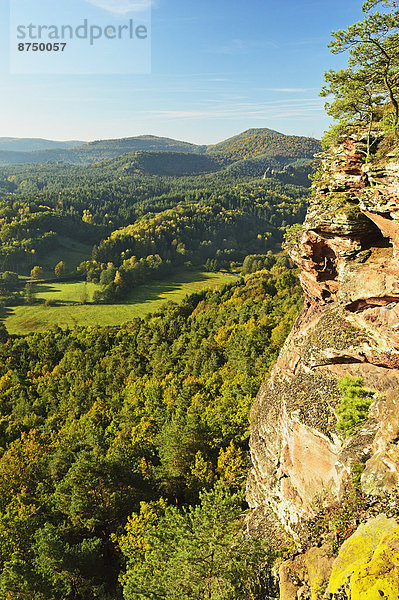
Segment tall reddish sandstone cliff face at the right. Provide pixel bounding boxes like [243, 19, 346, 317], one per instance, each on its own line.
[247, 138, 399, 544]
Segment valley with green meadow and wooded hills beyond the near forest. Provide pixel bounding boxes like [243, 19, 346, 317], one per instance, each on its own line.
[0, 129, 312, 334]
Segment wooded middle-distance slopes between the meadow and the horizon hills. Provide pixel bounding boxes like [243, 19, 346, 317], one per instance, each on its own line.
[0, 155, 306, 276]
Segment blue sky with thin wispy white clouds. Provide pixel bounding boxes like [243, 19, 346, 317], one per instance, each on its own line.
[0, 0, 368, 144]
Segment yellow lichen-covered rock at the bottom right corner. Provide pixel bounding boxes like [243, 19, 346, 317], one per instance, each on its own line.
[279, 514, 399, 600]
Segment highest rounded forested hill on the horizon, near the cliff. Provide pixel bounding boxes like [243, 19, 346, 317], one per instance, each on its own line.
[207, 128, 321, 163]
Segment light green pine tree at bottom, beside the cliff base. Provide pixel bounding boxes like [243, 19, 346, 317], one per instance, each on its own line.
[120, 484, 271, 600]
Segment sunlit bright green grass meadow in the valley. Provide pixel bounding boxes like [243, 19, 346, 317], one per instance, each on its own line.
[0, 271, 233, 335]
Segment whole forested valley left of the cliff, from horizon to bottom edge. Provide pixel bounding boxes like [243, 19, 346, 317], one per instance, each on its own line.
[0, 129, 310, 600]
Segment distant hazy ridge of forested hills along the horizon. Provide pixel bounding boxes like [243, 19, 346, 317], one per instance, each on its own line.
[0, 129, 321, 165]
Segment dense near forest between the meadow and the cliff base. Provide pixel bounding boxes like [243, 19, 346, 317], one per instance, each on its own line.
[0, 264, 301, 600]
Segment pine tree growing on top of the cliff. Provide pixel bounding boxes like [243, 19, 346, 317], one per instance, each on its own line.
[321, 0, 399, 144]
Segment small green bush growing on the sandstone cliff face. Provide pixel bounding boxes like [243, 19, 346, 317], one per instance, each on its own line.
[336, 376, 375, 436]
